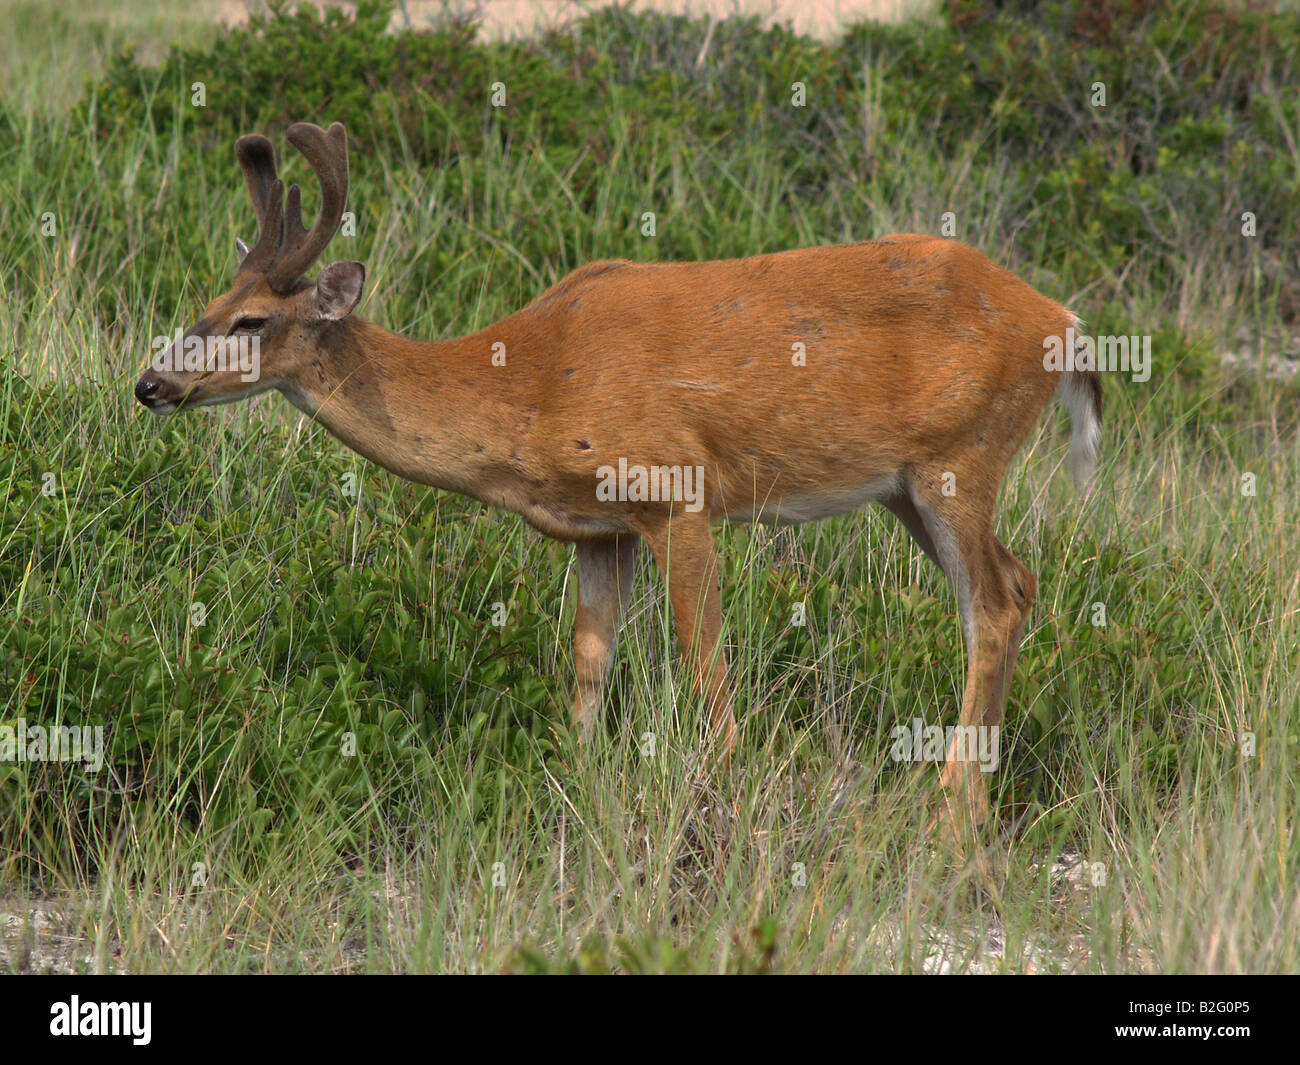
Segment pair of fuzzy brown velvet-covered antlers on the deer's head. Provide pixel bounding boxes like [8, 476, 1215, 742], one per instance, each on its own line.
[235, 122, 347, 293]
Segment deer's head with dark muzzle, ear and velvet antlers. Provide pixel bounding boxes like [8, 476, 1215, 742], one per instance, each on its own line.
[135, 122, 365, 414]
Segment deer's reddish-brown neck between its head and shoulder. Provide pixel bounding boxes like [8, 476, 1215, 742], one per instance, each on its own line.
[281, 316, 536, 502]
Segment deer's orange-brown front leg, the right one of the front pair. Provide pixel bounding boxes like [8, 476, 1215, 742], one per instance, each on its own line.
[642, 511, 736, 761]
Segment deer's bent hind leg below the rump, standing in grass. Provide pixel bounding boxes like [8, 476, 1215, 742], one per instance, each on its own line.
[909, 473, 1036, 843]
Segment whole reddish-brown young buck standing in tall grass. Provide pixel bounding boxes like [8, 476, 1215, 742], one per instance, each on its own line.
[135, 122, 1101, 830]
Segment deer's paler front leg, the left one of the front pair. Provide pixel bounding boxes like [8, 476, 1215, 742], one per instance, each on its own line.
[573, 534, 637, 740]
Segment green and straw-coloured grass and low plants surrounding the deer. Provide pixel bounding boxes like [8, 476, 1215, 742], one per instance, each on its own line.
[0, 4, 1300, 971]
